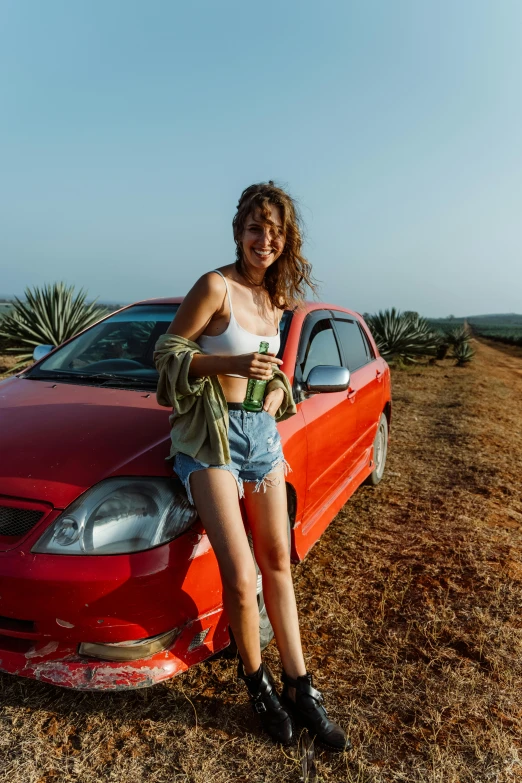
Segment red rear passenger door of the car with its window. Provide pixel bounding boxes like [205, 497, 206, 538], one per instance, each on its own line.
[334, 311, 383, 456]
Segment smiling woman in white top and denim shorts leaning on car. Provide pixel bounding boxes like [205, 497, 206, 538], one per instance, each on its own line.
[155, 182, 350, 750]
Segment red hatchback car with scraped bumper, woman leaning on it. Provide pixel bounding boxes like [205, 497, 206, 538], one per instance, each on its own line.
[0, 299, 391, 690]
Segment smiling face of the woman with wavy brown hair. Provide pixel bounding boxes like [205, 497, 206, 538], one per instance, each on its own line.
[241, 204, 285, 272]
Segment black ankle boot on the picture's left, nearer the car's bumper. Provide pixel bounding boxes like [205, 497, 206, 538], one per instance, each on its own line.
[237, 660, 294, 745]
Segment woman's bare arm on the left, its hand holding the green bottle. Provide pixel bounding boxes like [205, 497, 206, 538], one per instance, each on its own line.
[167, 272, 282, 381]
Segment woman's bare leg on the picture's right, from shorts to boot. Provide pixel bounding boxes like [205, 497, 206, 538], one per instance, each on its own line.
[243, 465, 306, 678]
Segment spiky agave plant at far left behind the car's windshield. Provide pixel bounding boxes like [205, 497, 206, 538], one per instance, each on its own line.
[0, 283, 106, 369]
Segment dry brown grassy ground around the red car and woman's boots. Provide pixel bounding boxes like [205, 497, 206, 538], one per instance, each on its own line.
[0, 342, 522, 783]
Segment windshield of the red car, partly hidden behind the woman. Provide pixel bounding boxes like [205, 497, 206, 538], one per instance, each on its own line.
[26, 304, 292, 389]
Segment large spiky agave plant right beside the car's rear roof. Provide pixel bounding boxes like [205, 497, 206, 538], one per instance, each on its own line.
[365, 307, 440, 362]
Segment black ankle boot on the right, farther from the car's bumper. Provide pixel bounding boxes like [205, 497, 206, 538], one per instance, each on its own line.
[281, 671, 352, 750]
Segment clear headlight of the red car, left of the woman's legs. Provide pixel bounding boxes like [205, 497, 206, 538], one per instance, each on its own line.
[32, 478, 197, 555]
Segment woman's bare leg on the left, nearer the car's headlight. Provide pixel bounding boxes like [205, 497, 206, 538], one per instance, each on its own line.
[190, 468, 261, 674]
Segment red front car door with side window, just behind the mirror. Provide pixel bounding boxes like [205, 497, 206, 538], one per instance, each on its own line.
[295, 311, 357, 532]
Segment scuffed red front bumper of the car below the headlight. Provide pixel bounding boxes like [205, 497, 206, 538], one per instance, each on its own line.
[0, 525, 229, 690]
